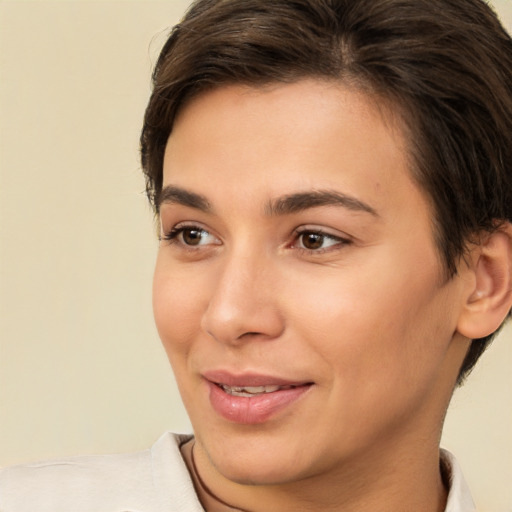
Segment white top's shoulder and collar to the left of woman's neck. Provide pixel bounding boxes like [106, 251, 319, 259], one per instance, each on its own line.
[0, 433, 202, 512]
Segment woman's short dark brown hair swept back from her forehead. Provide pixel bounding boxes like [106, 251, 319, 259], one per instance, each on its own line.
[141, 0, 512, 383]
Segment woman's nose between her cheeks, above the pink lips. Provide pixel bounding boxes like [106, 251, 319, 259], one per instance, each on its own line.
[201, 253, 284, 344]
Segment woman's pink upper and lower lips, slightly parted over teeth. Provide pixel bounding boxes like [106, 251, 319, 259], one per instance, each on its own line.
[203, 372, 311, 425]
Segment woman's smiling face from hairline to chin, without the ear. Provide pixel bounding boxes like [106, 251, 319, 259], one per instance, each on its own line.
[154, 80, 465, 484]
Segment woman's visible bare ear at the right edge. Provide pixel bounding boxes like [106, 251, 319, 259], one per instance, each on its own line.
[457, 222, 512, 339]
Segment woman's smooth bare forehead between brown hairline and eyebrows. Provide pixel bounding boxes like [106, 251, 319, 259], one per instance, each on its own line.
[164, 80, 416, 206]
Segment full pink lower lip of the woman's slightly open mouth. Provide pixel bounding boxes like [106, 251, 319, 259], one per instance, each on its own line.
[207, 381, 311, 425]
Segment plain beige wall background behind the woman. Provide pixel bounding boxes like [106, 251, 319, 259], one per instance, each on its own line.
[0, 0, 512, 512]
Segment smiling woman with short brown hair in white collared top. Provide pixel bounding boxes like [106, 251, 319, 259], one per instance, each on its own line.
[0, 0, 512, 512]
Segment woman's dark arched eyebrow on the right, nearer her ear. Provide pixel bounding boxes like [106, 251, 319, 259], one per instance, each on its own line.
[265, 190, 379, 217]
